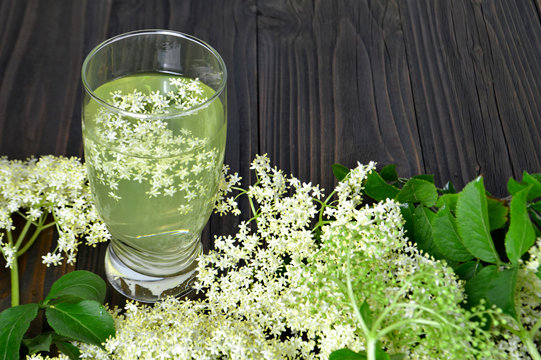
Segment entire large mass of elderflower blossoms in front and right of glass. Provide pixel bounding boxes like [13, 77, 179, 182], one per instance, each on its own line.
[31, 156, 512, 360]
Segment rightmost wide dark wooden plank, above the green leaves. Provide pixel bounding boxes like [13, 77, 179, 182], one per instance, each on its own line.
[399, 1, 541, 195]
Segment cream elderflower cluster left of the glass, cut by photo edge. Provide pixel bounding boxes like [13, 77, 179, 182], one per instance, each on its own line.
[0, 156, 110, 267]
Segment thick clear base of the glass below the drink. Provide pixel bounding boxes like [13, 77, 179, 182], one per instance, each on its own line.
[105, 244, 197, 303]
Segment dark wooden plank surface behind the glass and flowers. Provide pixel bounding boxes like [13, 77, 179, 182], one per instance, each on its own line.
[0, 0, 541, 332]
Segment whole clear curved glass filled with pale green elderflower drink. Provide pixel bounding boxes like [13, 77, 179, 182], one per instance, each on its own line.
[82, 30, 227, 302]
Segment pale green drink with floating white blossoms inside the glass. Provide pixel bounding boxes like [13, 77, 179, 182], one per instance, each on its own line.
[83, 73, 226, 276]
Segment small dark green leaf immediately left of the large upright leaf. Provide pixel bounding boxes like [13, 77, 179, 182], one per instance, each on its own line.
[432, 207, 473, 262]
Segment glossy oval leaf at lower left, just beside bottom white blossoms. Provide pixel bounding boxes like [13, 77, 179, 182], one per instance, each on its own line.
[45, 300, 115, 345]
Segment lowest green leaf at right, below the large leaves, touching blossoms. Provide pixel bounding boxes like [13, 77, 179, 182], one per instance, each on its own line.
[486, 267, 518, 320]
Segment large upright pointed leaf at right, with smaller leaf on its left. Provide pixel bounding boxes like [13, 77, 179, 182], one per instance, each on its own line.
[456, 177, 500, 263]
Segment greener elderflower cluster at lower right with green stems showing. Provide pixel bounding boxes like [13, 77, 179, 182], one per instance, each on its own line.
[305, 164, 499, 359]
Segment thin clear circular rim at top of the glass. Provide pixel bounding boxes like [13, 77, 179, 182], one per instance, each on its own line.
[81, 29, 227, 119]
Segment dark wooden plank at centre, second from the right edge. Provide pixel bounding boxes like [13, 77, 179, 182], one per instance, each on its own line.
[258, 1, 423, 197]
